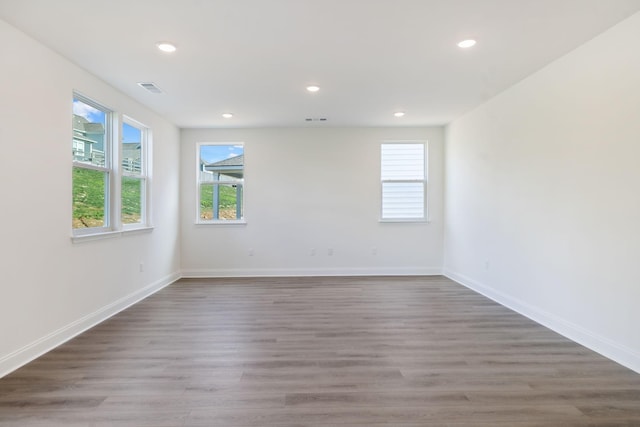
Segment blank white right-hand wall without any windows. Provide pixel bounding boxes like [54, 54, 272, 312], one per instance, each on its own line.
[444, 14, 640, 372]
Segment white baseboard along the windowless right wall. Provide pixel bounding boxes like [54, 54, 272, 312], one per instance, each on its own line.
[443, 269, 640, 373]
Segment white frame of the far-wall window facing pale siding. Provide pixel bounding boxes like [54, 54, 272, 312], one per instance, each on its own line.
[380, 140, 429, 222]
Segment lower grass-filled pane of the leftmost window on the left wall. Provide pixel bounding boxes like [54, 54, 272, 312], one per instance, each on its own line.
[73, 167, 109, 228]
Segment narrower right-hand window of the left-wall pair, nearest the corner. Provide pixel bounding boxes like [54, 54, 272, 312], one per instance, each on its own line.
[120, 117, 148, 228]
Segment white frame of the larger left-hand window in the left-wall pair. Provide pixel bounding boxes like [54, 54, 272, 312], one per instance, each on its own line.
[71, 92, 114, 236]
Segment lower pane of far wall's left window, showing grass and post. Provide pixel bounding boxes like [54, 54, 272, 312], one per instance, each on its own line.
[199, 183, 242, 220]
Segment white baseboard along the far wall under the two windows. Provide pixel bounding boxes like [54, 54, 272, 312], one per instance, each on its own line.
[182, 267, 442, 278]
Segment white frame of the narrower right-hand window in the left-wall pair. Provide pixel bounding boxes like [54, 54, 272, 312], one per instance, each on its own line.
[118, 115, 151, 230]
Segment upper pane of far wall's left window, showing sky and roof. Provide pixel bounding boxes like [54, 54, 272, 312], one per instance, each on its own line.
[200, 145, 244, 182]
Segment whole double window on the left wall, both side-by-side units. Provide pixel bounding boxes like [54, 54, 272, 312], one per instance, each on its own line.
[72, 94, 149, 236]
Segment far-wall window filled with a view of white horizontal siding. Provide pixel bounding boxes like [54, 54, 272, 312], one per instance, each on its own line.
[380, 142, 427, 221]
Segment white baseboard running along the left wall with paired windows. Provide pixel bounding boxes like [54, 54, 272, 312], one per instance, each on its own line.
[0, 273, 181, 378]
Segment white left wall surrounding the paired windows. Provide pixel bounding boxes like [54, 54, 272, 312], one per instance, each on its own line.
[0, 21, 180, 377]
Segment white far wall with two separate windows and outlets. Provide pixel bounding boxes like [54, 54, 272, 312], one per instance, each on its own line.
[181, 128, 443, 276]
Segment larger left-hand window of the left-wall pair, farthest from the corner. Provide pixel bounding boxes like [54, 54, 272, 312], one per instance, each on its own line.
[72, 96, 113, 234]
